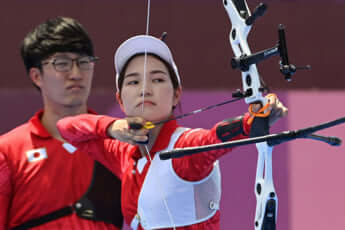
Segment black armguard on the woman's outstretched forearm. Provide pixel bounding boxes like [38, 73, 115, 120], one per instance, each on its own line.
[216, 116, 244, 142]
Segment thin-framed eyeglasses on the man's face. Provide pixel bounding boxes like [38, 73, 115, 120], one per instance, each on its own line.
[42, 56, 99, 72]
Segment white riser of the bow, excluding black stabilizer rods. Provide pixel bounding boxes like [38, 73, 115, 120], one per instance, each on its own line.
[223, 0, 280, 230]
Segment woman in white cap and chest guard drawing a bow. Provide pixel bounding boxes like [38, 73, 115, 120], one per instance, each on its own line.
[58, 35, 287, 229]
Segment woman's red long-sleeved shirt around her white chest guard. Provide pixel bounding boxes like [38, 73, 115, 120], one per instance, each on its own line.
[57, 114, 250, 230]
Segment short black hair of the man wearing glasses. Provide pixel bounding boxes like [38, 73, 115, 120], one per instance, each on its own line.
[20, 17, 94, 73]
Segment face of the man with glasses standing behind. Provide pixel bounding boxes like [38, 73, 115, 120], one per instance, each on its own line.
[31, 52, 94, 107]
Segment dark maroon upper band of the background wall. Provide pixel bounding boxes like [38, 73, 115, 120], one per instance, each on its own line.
[0, 0, 345, 89]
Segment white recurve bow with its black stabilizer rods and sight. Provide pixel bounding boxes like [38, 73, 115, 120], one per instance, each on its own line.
[155, 0, 345, 230]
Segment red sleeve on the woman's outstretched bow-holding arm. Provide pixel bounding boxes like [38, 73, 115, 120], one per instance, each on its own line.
[172, 113, 250, 181]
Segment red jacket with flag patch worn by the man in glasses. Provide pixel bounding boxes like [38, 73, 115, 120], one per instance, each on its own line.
[0, 111, 118, 230]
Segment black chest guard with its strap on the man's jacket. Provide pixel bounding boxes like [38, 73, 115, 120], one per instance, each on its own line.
[12, 161, 123, 230]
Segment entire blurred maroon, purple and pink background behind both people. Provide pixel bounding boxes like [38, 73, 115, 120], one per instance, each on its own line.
[0, 0, 345, 230]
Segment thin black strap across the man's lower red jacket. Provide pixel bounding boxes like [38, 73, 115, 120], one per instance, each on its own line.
[12, 206, 73, 230]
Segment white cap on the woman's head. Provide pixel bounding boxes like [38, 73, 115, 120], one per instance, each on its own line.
[114, 35, 181, 91]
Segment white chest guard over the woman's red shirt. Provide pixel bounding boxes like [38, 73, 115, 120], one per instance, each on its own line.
[137, 128, 221, 229]
